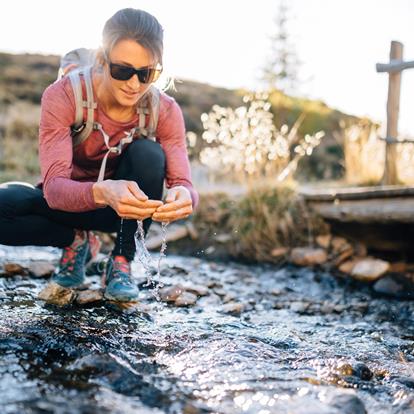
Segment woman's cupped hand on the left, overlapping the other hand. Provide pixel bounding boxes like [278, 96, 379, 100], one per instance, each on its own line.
[92, 180, 163, 220]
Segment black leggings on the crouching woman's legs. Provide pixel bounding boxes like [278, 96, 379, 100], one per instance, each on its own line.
[0, 139, 165, 260]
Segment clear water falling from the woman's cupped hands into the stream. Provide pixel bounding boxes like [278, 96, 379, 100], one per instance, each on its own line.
[135, 220, 168, 300]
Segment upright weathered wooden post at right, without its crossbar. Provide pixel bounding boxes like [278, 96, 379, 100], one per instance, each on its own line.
[382, 41, 403, 185]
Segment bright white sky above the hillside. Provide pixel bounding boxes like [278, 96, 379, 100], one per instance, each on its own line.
[0, 0, 414, 138]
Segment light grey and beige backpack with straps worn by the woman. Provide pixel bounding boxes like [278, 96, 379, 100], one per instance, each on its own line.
[58, 48, 160, 181]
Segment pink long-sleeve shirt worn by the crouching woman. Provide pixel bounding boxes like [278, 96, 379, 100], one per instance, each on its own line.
[39, 77, 198, 212]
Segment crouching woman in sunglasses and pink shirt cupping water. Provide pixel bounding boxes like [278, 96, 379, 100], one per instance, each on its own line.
[0, 9, 198, 301]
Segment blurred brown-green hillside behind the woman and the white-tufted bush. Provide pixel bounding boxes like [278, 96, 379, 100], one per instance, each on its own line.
[0, 53, 372, 178]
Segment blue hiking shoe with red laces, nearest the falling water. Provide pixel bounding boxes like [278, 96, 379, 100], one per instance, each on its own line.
[103, 256, 138, 302]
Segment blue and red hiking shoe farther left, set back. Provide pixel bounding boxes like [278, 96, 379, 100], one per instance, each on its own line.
[52, 230, 89, 288]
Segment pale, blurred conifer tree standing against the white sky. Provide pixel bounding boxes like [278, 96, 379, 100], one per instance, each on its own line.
[261, 0, 301, 94]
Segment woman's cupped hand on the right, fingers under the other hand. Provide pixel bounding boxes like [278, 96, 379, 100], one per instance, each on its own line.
[152, 186, 193, 222]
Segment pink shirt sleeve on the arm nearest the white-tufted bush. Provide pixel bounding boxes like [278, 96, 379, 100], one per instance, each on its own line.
[157, 97, 199, 208]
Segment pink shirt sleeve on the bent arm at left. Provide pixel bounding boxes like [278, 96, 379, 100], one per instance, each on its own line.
[39, 79, 99, 212]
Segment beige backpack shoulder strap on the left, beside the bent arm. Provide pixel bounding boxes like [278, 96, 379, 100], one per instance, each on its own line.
[68, 66, 97, 147]
